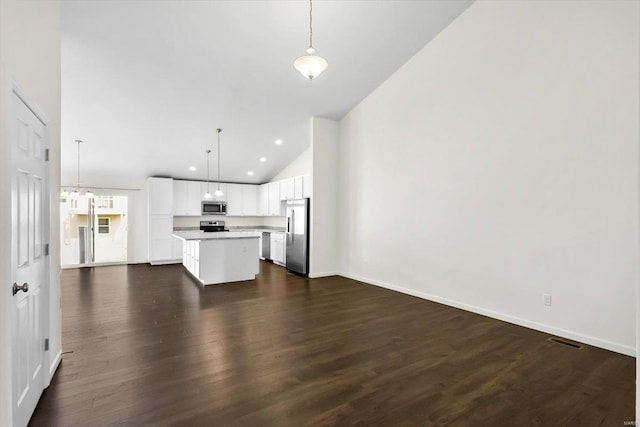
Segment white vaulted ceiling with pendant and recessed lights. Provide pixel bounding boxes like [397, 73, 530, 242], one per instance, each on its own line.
[62, 0, 472, 184]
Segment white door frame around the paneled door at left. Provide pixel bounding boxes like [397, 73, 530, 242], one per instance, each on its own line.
[0, 72, 53, 426]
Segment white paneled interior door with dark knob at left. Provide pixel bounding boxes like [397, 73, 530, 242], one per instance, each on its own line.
[9, 93, 49, 426]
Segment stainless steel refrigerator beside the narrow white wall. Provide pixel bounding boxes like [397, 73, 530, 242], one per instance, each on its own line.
[285, 199, 309, 275]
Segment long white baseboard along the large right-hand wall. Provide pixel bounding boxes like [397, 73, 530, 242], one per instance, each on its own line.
[338, 273, 636, 357]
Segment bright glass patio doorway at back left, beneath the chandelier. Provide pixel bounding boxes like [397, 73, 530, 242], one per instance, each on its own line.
[60, 193, 129, 268]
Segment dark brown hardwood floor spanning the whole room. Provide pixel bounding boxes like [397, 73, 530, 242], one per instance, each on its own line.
[31, 263, 635, 426]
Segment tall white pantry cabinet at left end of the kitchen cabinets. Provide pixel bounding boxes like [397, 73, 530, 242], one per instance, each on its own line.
[147, 178, 175, 264]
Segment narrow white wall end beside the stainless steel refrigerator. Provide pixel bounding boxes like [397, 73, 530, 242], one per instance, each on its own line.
[309, 117, 342, 277]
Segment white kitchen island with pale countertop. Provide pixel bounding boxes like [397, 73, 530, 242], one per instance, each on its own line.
[173, 230, 260, 285]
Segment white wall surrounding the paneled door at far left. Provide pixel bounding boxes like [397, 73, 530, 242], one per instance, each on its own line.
[0, 0, 61, 425]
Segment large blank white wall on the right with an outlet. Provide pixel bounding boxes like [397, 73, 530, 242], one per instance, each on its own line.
[338, 0, 639, 354]
